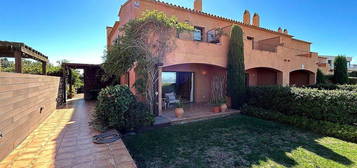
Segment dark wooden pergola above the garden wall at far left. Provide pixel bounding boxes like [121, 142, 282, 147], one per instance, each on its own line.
[0, 41, 48, 74]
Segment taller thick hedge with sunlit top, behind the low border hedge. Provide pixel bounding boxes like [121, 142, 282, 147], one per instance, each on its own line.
[247, 86, 357, 125]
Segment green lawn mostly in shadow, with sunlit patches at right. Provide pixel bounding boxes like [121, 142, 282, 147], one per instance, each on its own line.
[124, 115, 357, 168]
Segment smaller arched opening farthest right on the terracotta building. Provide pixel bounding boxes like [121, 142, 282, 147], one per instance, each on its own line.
[289, 70, 315, 87]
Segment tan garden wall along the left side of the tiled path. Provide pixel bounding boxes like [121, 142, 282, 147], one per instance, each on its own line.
[0, 72, 60, 161]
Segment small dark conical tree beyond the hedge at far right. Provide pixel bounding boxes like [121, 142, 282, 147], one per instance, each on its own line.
[333, 55, 348, 84]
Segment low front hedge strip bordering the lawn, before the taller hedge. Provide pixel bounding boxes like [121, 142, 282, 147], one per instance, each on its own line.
[242, 106, 357, 142]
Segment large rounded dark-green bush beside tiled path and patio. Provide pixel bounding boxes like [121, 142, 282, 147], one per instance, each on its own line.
[92, 85, 152, 131]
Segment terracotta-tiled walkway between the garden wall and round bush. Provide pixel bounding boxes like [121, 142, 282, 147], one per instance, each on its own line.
[0, 100, 135, 168]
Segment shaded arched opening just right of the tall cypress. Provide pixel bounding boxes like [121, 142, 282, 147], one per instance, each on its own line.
[246, 67, 283, 86]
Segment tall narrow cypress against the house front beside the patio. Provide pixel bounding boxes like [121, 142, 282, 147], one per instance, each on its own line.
[227, 25, 246, 109]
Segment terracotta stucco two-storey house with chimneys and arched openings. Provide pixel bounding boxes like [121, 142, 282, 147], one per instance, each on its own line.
[107, 0, 319, 113]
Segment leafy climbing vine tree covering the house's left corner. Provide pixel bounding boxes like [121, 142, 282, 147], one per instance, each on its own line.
[103, 10, 193, 113]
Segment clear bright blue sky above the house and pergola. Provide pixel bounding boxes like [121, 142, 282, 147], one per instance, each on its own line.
[0, 0, 357, 63]
